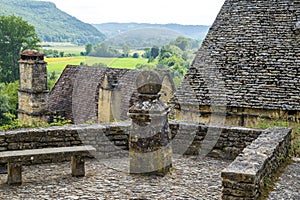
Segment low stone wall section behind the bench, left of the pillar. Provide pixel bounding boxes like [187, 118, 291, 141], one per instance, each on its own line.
[0, 122, 130, 162]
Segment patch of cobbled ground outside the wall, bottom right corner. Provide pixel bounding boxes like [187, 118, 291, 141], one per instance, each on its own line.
[268, 158, 300, 200]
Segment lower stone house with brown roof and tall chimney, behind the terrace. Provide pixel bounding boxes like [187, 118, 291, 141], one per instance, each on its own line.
[18, 50, 175, 124]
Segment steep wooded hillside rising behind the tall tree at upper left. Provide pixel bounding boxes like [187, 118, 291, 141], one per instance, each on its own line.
[0, 0, 105, 44]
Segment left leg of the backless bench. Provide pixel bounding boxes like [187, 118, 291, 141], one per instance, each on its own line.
[7, 162, 22, 185]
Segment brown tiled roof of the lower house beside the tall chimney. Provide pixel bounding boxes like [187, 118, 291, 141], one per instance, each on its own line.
[48, 65, 175, 124]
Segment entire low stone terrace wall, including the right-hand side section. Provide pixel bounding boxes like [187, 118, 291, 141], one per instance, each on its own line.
[0, 121, 291, 199]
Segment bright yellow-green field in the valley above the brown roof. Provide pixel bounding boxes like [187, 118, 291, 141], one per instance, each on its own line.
[45, 56, 148, 74]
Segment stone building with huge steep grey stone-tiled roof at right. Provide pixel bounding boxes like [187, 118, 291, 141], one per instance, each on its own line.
[172, 0, 300, 126]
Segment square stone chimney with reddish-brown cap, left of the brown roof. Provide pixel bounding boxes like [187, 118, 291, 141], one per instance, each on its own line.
[18, 50, 49, 124]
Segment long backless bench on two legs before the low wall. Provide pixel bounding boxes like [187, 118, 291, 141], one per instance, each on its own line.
[0, 146, 96, 185]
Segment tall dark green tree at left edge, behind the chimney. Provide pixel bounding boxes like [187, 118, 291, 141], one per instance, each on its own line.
[0, 15, 40, 83]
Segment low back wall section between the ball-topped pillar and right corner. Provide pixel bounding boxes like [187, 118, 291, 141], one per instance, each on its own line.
[169, 121, 263, 160]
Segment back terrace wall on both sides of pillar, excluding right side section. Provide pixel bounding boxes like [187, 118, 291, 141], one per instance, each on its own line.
[0, 121, 263, 162]
